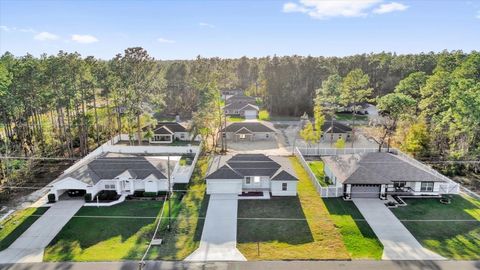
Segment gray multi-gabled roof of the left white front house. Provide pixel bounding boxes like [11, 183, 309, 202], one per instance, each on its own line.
[59, 153, 177, 185]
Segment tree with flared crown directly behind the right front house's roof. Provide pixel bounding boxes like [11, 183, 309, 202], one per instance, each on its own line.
[377, 93, 416, 152]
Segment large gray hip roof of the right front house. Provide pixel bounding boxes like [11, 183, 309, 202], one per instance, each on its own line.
[322, 152, 445, 184]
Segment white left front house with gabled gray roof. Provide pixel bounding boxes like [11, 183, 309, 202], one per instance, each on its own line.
[50, 153, 181, 199]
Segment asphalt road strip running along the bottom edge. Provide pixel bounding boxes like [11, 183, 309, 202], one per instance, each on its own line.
[0, 261, 480, 270]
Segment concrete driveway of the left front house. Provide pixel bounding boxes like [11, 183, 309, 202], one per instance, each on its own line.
[0, 200, 85, 263]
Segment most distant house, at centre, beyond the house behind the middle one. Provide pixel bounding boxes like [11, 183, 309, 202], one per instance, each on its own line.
[223, 94, 259, 119]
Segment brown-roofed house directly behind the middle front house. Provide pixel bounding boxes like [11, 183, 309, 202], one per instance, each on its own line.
[221, 121, 275, 141]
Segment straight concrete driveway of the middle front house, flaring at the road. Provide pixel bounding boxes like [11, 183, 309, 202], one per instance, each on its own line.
[185, 194, 246, 261]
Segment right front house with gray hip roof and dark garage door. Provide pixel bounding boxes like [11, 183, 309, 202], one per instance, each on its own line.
[322, 152, 451, 199]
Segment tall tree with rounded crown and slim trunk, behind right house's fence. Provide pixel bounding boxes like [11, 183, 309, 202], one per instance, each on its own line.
[340, 68, 373, 148]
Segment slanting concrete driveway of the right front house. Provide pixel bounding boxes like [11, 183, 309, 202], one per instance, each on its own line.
[353, 199, 445, 260]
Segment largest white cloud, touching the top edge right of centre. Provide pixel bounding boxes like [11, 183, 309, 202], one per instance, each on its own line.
[283, 0, 408, 19]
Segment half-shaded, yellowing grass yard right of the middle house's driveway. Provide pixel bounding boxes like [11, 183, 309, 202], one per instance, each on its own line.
[237, 157, 350, 260]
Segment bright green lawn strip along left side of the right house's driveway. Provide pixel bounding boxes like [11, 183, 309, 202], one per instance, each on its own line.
[323, 198, 383, 260]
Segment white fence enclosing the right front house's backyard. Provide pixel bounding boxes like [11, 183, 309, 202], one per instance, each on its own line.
[295, 147, 460, 194]
